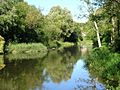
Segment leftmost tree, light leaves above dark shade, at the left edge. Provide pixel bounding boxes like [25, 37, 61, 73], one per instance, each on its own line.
[0, 0, 23, 42]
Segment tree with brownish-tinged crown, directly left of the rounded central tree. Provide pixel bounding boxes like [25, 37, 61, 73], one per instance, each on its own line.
[16, 2, 43, 42]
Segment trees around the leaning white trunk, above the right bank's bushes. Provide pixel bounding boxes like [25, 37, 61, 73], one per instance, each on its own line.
[83, 0, 120, 52]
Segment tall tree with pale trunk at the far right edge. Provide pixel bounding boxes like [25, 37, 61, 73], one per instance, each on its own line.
[93, 0, 120, 51]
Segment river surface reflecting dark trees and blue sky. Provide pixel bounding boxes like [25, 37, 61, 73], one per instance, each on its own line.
[0, 46, 105, 90]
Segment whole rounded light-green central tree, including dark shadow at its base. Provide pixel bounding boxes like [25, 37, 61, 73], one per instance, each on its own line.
[44, 6, 78, 46]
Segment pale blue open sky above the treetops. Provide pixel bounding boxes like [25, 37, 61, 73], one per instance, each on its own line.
[24, 0, 88, 23]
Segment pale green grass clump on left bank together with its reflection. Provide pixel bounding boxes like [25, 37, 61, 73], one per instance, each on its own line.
[6, 43, 47, 60]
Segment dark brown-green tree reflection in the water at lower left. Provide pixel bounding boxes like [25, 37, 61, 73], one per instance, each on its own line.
[0, 60, 43, 90]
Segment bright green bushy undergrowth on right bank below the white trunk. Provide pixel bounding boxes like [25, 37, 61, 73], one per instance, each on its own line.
[86, 47, 120, 90]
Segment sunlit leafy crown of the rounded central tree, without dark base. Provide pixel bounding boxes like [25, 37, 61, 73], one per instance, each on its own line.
[45, 6, 73, 44]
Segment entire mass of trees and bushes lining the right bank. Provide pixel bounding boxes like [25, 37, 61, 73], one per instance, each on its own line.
[83, 0, 120, 90]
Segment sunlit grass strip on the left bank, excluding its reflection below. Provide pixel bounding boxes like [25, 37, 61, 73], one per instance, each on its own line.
[9, 43, 47, 53]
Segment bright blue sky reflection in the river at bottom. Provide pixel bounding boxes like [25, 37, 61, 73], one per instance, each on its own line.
[39, 59, 105, 90]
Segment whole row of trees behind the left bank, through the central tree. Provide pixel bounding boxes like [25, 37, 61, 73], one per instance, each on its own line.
[0, 0, 81, 47]
